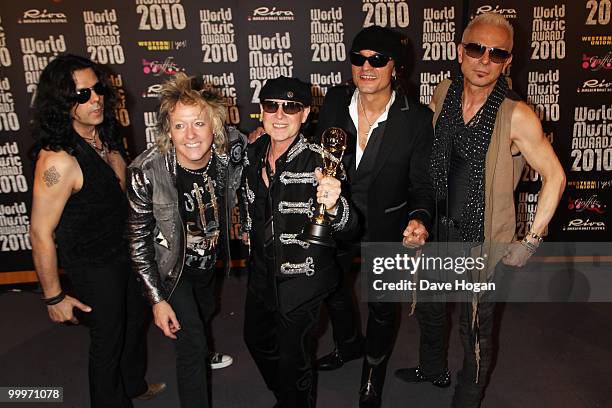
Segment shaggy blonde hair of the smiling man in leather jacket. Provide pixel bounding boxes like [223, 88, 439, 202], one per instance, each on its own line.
[156, 72, 227, 153]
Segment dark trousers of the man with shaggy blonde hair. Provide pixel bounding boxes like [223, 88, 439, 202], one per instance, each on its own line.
[169, 271, 215, 408]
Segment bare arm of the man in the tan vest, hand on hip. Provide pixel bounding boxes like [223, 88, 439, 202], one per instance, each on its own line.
[503, 102, 565, 266]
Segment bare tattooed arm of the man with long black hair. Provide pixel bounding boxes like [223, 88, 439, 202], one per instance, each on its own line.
[30, 150, 88, 323]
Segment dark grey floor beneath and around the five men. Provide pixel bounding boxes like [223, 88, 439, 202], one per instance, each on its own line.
[0, 278, 612, 408]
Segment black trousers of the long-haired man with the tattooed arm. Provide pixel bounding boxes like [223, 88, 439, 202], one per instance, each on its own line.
[66, 258, 151, 408]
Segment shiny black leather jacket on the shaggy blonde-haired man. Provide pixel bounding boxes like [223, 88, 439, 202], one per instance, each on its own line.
[127, 131, 250, 305]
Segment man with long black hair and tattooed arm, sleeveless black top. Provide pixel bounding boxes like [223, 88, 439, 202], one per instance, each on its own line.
[31, 55, 165, 408]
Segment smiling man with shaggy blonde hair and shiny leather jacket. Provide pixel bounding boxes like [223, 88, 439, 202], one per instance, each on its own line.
[127, 73, 246, 408]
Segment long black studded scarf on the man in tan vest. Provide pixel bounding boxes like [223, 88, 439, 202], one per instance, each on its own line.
[430, 74, 508, 242]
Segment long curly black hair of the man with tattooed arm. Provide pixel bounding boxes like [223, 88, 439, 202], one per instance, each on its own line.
[30, 54, 123, 161]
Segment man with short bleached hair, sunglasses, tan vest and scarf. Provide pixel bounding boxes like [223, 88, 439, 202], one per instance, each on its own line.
[396, 13, 565, 408]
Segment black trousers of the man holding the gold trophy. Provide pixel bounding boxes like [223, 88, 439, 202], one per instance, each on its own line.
[244, 291, 321, 408]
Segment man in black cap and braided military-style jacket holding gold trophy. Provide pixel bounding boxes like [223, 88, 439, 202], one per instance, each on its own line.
[244, 76, 356, 408]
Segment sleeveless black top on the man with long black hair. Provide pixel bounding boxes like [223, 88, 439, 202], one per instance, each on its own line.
[55, 137, 128, 268]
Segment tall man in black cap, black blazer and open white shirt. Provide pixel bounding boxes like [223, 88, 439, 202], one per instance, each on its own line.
[318, 26, 434, 407]
